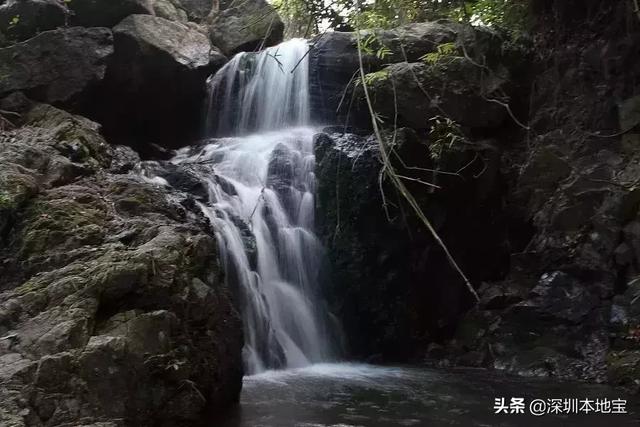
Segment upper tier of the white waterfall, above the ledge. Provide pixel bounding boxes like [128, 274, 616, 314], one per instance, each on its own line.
[206, 39, 310, 136]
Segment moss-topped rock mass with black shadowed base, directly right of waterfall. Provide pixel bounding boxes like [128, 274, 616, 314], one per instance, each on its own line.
[312, 21, 526, 361]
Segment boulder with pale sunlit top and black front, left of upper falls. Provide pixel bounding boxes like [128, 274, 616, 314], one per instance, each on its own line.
[96, 15, 226, 150]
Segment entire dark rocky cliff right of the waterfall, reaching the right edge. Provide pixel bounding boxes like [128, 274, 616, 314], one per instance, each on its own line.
[314, 0, 640, 387]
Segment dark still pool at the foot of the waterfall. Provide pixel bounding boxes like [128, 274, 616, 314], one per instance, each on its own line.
[214, 364, 640, 427]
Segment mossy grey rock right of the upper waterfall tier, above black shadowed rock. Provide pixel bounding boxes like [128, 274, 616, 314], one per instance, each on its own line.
[310, 21, 508, 128]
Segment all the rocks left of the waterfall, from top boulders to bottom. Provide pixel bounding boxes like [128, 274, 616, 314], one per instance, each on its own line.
[0, 0, 286, 427]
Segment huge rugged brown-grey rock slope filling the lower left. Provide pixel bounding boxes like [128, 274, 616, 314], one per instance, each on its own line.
[0, 99, 242, 427]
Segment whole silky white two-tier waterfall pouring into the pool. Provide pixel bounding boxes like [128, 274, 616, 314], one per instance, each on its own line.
[173, 40, 333, 374]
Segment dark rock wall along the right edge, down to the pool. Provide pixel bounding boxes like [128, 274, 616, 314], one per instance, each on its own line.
[472, 1, 640, 385]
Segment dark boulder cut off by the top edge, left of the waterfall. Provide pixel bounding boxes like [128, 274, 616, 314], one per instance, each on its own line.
[69, 0, 153, 27]
